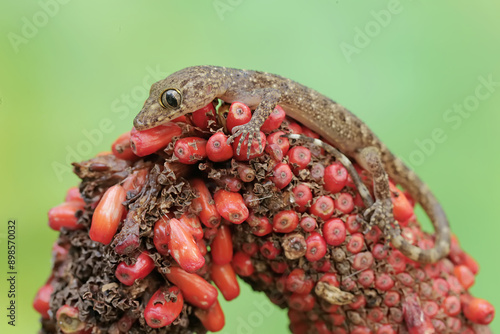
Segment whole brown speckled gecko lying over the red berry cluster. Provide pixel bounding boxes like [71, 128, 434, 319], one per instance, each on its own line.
[134, 66, 450, 263]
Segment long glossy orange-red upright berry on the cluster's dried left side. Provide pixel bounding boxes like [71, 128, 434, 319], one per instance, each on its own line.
[89, 184, 127, 245]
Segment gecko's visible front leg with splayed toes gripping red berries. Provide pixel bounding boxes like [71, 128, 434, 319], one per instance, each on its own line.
[228, 88, 281, 159]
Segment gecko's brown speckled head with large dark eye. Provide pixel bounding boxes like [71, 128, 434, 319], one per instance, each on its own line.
[134, 67, 216, 131]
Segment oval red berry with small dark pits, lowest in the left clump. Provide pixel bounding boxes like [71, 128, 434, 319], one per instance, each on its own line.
[144, 286, 184, 328]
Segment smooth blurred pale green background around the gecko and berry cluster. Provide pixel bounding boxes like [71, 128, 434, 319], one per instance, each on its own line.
[0, 0, 500, 334]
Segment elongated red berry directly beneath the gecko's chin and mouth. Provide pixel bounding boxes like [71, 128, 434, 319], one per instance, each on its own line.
[130, 122, 182, 157]
